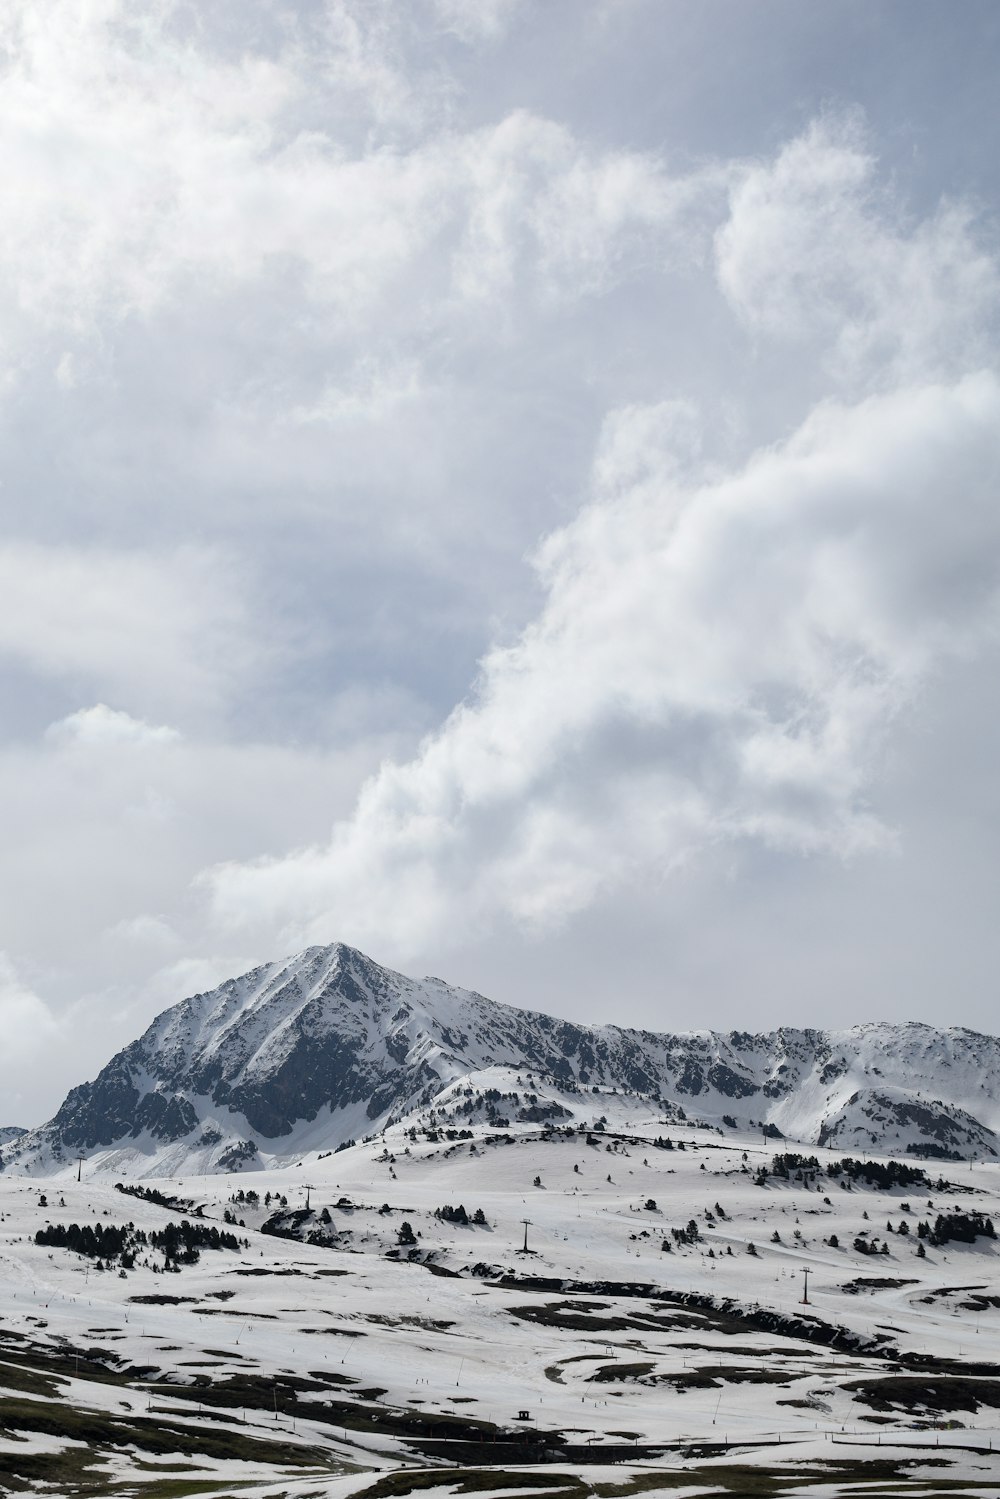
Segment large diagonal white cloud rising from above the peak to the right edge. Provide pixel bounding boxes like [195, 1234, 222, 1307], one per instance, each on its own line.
[208, 375, 1000, 952]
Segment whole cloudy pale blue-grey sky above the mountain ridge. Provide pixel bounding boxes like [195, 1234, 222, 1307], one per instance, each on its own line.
[0, 0, 1000, 1124]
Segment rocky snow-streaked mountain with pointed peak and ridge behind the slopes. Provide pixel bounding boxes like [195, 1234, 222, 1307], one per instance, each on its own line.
[0, 944, 1000, 1175]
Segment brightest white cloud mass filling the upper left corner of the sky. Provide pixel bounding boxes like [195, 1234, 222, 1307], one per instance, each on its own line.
[0, 0, 719, 371]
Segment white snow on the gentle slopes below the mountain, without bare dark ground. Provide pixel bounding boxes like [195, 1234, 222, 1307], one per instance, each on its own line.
[0, 1069, 1000, 1493]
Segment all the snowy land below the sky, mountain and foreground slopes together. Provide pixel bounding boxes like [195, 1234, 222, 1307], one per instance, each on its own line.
[0, 944, 1000, 1499]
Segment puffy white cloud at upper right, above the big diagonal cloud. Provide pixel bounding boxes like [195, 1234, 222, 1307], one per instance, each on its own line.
[715, 115, 1000, 379]
